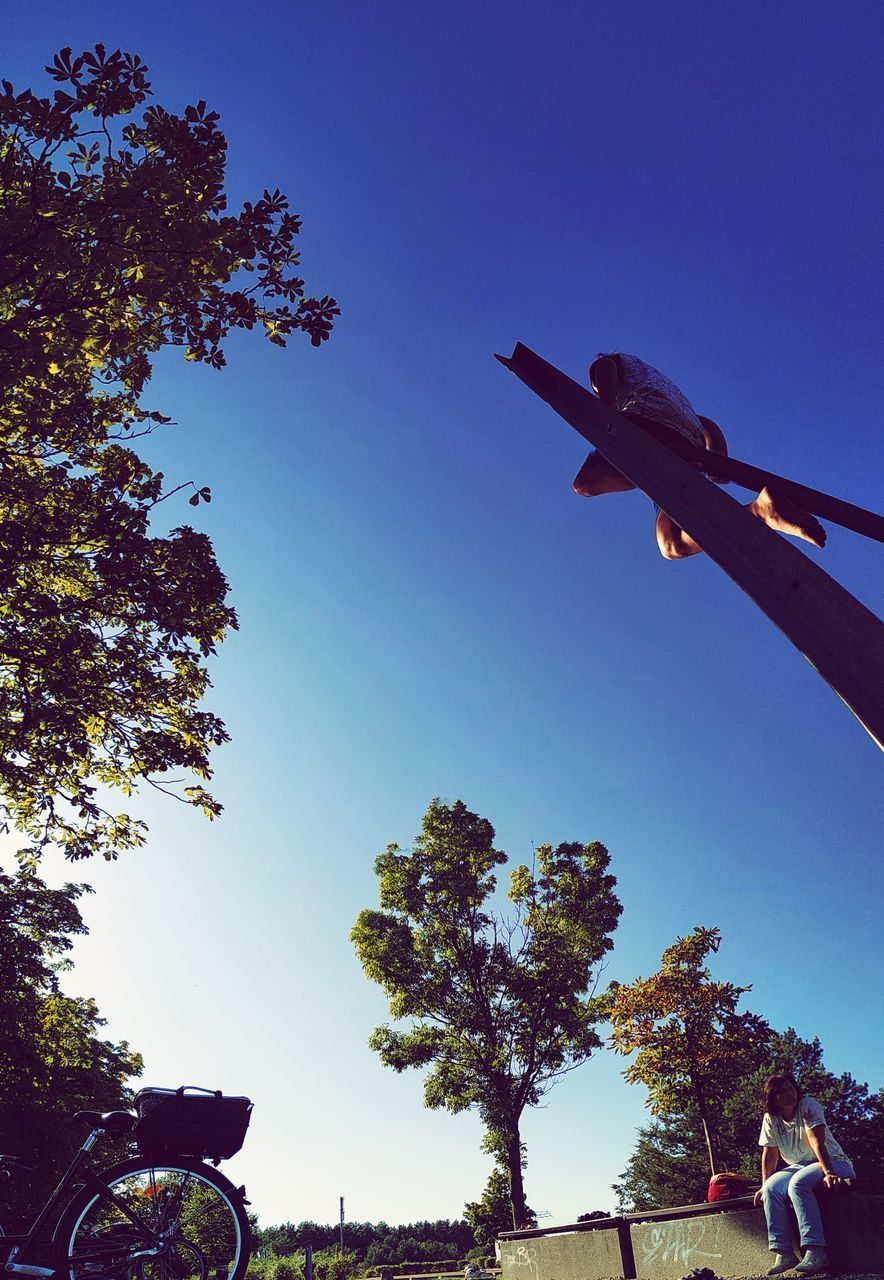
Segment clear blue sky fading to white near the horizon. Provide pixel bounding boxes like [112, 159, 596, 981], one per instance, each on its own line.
[3, 0, 884, 1224]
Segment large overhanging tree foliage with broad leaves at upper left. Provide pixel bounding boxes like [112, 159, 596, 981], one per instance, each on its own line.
[0, 45, 339, 864]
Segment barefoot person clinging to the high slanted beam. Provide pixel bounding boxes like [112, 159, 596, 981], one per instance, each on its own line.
[574, 351, 825, 559]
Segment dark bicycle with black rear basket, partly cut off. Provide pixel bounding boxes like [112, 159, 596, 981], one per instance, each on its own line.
[0, 1088, 252, 1280]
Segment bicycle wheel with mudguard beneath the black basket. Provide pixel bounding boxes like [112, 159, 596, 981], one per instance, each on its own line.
[54, 1156, 251, 1280]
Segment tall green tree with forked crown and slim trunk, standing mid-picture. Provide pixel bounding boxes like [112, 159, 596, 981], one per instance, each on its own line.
[351, 800, 622, 1225]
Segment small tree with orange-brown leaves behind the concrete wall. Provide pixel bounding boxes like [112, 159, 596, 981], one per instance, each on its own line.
[609, 925, 770, 1172]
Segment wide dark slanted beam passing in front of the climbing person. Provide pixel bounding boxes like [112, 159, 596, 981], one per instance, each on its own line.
[496, 343, 884, 750]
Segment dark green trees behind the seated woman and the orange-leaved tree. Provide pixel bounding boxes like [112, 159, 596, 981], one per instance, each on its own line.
[614, 1028, 884, 1211]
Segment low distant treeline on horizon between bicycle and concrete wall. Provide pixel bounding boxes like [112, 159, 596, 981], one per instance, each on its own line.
[256, 1219, 476, 1266]
